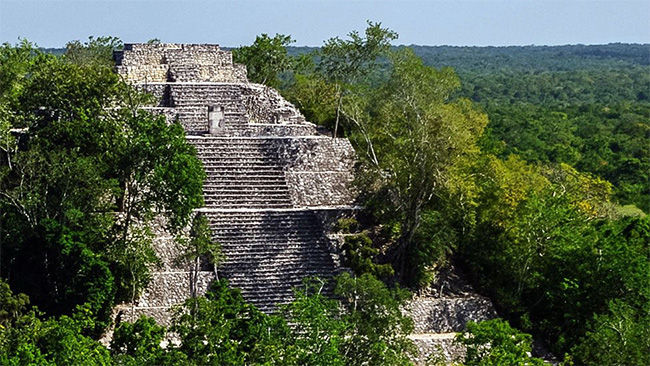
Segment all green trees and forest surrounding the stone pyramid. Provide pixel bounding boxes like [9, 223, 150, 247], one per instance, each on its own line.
[0, 30, 650, 365]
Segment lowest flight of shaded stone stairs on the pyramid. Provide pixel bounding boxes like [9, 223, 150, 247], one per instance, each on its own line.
[205, 209, 338, 312]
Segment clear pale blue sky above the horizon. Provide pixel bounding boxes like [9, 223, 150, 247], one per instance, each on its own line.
[0, 0, 650, 48]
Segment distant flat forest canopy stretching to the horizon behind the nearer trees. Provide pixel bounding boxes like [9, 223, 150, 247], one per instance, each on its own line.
[287, 43, 650, 213]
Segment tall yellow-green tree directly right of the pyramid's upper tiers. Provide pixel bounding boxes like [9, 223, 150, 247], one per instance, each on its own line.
[342, 49, 487, 274]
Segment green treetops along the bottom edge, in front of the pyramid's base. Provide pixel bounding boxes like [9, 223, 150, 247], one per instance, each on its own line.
[104, 274, 414, 366]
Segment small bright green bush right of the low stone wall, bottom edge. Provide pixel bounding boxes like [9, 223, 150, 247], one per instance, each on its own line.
[456, 319, 544, 366]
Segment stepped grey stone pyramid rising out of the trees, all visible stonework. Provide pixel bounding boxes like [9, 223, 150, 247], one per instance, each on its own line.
[114, 44, 496, 363]
